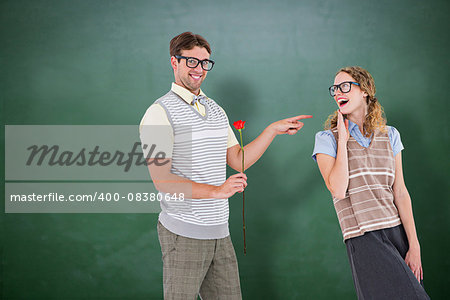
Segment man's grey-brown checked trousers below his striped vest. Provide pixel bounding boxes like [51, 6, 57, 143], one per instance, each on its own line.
[157, 222, 242, 300]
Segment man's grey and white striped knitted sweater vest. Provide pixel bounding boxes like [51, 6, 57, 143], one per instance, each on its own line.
[156, 91, 229, 239]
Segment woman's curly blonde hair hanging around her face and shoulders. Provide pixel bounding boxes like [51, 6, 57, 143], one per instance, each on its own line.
[324, 66, 386, 137]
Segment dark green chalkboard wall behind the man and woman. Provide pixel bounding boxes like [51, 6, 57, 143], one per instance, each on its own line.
[0, 0, 450, 299]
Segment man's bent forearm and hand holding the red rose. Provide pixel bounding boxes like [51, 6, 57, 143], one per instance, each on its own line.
[147, 159, 247, 199]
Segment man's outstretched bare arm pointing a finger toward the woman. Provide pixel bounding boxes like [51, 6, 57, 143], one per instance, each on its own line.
[227, 115, 312, 172]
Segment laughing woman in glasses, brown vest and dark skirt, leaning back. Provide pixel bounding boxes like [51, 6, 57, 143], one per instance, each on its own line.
[313, 67, 429, 299]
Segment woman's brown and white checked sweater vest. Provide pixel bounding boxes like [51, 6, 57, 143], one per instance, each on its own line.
[332, 129, 401, 241]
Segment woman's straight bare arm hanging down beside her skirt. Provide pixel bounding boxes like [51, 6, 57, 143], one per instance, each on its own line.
[393, 152, 423, 282]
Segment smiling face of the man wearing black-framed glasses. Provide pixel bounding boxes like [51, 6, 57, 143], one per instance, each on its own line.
[170, 46, 209, 95]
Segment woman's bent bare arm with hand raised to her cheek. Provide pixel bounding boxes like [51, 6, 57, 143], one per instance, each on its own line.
[316, 112, 350, 199]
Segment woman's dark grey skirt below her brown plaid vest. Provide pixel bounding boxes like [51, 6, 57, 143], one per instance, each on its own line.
[345, 225, 430, 300]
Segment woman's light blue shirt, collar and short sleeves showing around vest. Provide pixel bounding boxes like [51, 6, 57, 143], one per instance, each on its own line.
[312, 120, 404, 160]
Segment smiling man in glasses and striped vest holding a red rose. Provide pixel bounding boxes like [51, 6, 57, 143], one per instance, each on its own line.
[141, 32, 312, 300]
